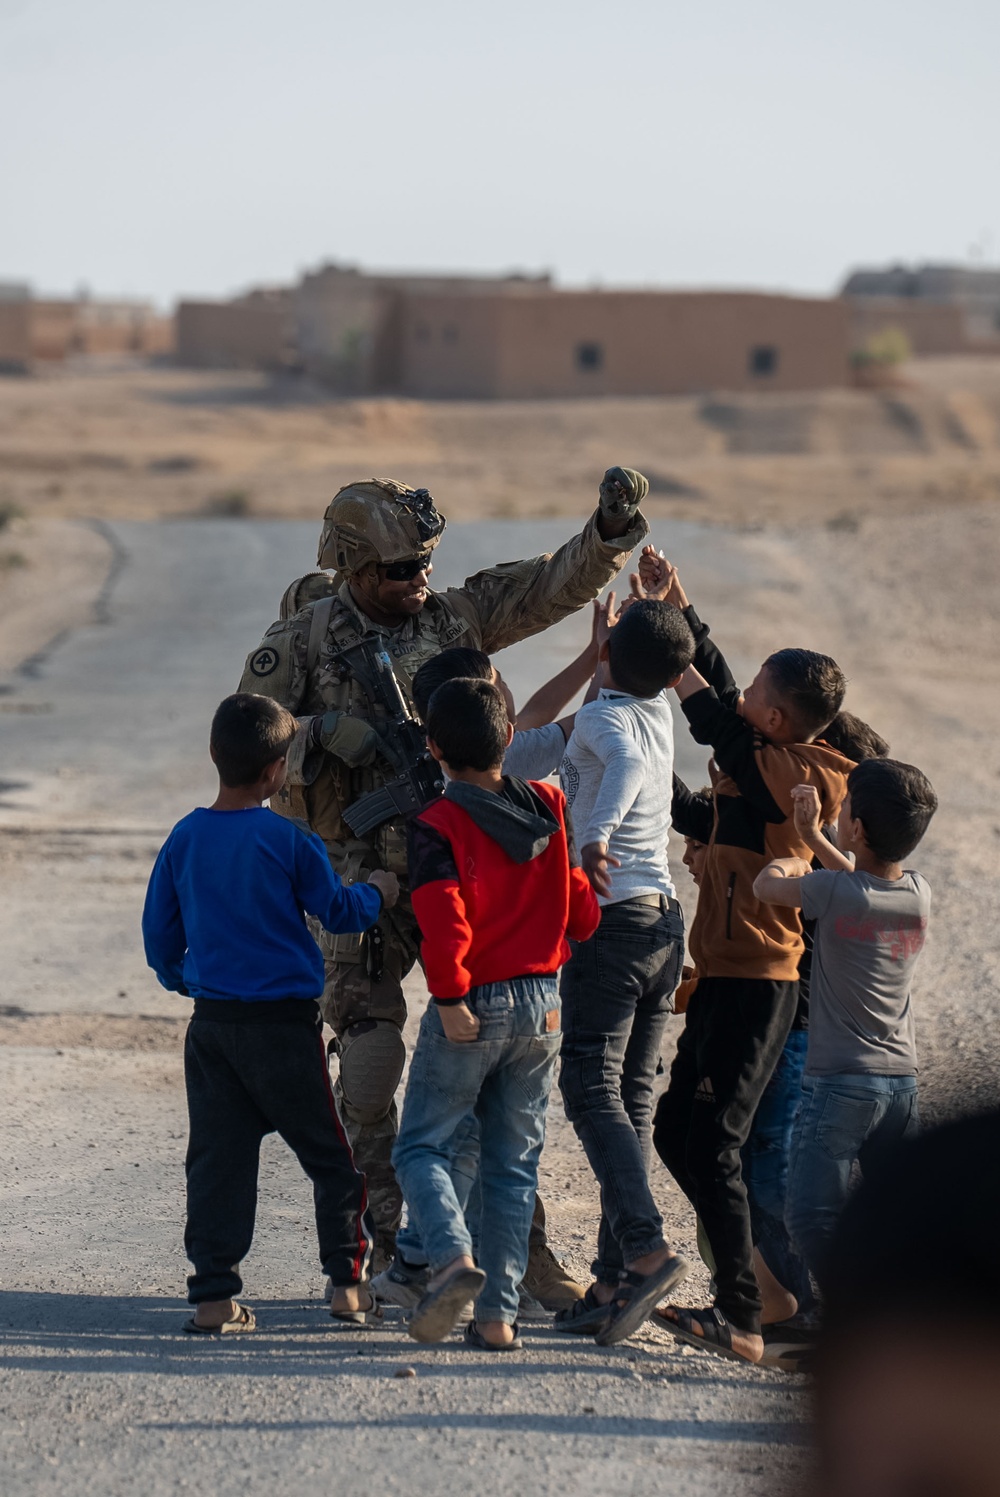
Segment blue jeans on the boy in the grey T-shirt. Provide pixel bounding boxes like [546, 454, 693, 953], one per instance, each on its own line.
[787, 1075, 918, 1289]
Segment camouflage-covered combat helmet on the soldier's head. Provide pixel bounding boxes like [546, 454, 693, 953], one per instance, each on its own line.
[319, 478, 445, 576]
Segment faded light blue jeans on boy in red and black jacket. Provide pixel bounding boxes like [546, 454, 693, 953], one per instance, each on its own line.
[392, 978, 563, 1325]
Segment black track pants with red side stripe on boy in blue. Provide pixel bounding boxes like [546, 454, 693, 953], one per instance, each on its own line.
[184, 998, 373, 1304]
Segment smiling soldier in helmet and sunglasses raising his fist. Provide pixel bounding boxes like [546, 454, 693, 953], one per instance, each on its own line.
[240, 467, 648, 1299]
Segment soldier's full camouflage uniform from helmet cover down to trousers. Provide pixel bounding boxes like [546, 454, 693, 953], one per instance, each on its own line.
[240, 481, 648, 1254]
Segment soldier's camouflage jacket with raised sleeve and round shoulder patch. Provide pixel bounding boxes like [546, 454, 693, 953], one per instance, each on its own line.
[240, 513, 648, 879]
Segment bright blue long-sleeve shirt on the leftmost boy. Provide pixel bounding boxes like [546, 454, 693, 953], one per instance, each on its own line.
[142, 807, 382, 1003]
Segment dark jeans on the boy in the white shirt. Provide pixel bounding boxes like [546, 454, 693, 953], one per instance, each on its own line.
[558, 898, 684, 1284]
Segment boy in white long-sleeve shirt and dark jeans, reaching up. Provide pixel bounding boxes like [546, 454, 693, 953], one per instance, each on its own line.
[555, 599, 695, 1346]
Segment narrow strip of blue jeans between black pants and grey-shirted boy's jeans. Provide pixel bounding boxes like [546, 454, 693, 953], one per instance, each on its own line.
[743, 1030, 816, 1314]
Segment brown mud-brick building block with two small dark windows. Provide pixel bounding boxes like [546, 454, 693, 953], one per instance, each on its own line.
[395, 289, 849, 400]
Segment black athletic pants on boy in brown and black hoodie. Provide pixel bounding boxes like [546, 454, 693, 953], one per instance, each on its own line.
[653, 978, 798, 1334]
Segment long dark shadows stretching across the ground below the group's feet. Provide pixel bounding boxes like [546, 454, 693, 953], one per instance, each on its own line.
[0, 1290, 808, 1446]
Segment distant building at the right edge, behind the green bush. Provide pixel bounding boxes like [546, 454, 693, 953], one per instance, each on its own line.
[841, 265, 1000, 353]
